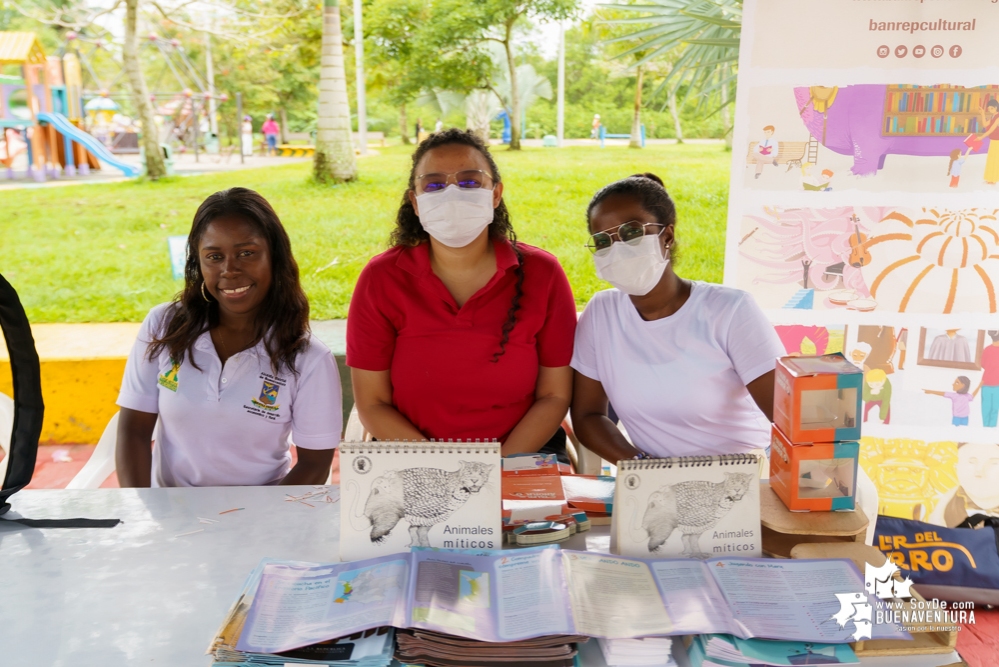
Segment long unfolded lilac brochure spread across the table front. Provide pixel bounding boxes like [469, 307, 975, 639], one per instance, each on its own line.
[230, 546, 909, 653]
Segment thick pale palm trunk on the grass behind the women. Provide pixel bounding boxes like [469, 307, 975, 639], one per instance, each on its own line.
[312, 0, 357, 183]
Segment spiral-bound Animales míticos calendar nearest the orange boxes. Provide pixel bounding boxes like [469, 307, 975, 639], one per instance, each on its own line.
[611, 454, 763, 559]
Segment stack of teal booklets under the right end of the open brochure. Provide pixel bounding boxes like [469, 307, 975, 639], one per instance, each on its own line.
[689, 635, 860, 667]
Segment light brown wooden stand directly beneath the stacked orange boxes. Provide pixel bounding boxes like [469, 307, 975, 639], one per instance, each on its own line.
[760, 481, 868, 558]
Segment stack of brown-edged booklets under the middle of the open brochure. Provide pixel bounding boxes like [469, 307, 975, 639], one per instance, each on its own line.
[395, 630, 587, 667]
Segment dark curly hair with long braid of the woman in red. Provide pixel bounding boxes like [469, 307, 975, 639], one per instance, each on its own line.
[389, 127, 524, 363]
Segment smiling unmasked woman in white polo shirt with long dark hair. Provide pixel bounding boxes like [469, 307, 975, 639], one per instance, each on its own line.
[116, 188, 342, 487]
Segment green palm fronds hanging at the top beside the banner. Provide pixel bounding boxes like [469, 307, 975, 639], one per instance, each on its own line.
[601, 0, 742, 115]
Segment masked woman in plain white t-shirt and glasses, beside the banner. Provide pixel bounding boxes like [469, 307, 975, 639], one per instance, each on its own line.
[572, 174, 784, 461]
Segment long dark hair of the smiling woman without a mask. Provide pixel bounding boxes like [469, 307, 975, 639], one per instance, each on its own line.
[148, 188, 309, 373]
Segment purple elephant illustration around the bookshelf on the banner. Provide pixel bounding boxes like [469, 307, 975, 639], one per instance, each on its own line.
[794, 84, 988, 176]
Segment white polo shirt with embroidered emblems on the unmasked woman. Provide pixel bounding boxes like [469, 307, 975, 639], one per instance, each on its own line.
[118, 304, 343, 487]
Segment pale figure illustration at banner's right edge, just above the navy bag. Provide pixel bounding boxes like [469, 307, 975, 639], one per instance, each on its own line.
[927, 443, 999, 528]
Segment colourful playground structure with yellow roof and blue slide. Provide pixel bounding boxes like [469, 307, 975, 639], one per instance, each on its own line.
[0, 32, 139, 182]
